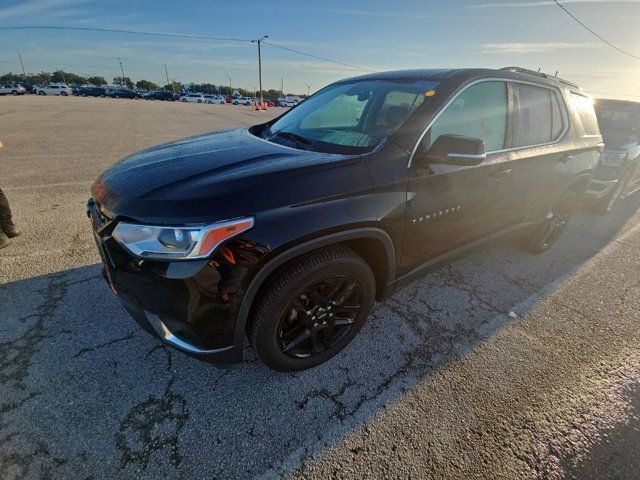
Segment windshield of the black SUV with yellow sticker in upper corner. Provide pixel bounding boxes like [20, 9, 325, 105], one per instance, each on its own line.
[263, 79, 438, 154]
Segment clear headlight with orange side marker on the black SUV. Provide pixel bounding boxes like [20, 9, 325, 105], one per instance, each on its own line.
[112, 217, 253, 260]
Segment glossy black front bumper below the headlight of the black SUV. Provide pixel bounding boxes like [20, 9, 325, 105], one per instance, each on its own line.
[87, 201, 256, 365]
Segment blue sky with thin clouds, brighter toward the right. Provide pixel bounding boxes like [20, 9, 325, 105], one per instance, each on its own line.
[0, 0, 640, 99]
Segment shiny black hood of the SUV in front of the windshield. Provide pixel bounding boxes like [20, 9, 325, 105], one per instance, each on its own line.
[91, 128, 351, 223]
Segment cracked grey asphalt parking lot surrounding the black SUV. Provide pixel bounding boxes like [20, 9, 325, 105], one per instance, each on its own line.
[0, 96, 640, 479]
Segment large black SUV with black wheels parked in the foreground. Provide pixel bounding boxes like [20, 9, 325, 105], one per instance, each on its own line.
[88, 69, 602, 371]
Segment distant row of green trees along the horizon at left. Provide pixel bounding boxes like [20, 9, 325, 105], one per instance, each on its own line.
[0, 70, 298, 100]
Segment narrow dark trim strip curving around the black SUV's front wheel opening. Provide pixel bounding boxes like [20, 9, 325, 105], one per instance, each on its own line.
[234, 227, 396, 349]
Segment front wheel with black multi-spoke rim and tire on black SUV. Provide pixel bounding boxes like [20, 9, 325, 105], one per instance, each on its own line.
[249, 246, 375, 372]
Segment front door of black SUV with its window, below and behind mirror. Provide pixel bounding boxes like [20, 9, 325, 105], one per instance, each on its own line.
[402, 80, 515, 272]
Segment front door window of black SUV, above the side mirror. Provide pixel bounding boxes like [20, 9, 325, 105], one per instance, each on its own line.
[425, 81, 508, 152]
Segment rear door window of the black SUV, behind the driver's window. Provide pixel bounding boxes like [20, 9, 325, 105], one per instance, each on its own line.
[512, 83, 564, 147]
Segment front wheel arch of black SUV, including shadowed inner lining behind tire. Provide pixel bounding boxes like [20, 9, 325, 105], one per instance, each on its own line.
[234, 227, 396, 345]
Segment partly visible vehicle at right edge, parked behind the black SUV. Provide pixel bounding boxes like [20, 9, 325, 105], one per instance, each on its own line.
[585, 99, 640, 214]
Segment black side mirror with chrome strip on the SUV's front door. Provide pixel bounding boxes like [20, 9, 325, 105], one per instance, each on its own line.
[414, 134, 487, 167]
